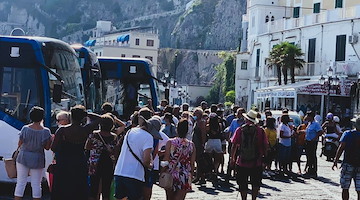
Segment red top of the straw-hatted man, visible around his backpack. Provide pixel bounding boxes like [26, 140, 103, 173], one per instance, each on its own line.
[231, 122, 268, 168]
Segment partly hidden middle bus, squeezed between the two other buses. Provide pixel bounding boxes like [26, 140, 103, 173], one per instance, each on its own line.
[71, 44, 103, 113]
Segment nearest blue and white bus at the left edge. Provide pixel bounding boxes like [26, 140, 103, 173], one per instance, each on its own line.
[0, 36, 85, 182]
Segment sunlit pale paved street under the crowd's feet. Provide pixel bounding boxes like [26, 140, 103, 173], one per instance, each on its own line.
[0, 143, 356, 200]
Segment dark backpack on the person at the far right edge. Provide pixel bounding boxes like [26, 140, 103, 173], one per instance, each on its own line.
[346, 131, 360, 167]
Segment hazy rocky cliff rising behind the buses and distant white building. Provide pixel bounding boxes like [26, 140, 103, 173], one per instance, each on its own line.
[0, 0, 246, 50]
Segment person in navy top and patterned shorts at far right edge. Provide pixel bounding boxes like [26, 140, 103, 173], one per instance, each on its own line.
[332, 117, 360, 200]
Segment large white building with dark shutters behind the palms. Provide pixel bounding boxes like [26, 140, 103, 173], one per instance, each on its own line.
[235, 0, 360, 118]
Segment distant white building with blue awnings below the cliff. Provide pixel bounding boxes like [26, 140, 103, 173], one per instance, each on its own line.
[85, 21, 160, 76]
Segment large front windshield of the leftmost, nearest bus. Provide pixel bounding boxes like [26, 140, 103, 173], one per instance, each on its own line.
[0, 66, 43, 123]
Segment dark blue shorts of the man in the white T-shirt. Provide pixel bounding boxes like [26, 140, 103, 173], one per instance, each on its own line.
[114, 175, 144, 200]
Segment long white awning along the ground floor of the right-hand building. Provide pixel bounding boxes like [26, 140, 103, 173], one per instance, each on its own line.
[255, 78, 351, 98]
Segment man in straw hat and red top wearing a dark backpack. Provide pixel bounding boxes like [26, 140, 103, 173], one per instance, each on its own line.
[231, 110, 267, 200]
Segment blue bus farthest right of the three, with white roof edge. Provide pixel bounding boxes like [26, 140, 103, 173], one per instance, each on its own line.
[99, 57, 158, 119]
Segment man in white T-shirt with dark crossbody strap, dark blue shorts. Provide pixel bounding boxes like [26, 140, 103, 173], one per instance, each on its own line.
[114, 115, 162, 199]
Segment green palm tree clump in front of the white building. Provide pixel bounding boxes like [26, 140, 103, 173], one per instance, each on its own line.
[269, 42, 305, 85]
